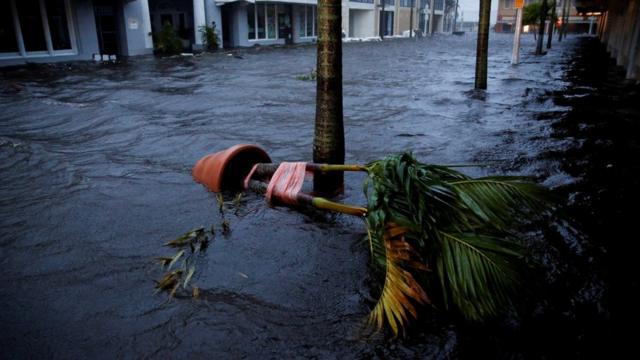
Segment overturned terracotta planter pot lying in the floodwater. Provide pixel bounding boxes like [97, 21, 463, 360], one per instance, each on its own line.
[192, 144, 271, 192]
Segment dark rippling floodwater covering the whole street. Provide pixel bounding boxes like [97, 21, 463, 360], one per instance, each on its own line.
[0, 34, 639, 358]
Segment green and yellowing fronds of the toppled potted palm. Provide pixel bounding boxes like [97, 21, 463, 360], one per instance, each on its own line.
[364, 153, 549, 335]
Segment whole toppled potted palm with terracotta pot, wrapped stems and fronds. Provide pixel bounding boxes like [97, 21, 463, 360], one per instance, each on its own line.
[193, 145, 549, 335]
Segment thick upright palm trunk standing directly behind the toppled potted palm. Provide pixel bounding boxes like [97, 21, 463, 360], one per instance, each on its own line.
[313, 0, 344, 194]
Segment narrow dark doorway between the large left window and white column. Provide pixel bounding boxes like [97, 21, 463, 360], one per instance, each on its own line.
[93, 0, 120, 55]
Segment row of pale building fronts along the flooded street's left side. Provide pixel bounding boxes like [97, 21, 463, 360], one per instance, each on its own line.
[0, 0, 444, 66]
